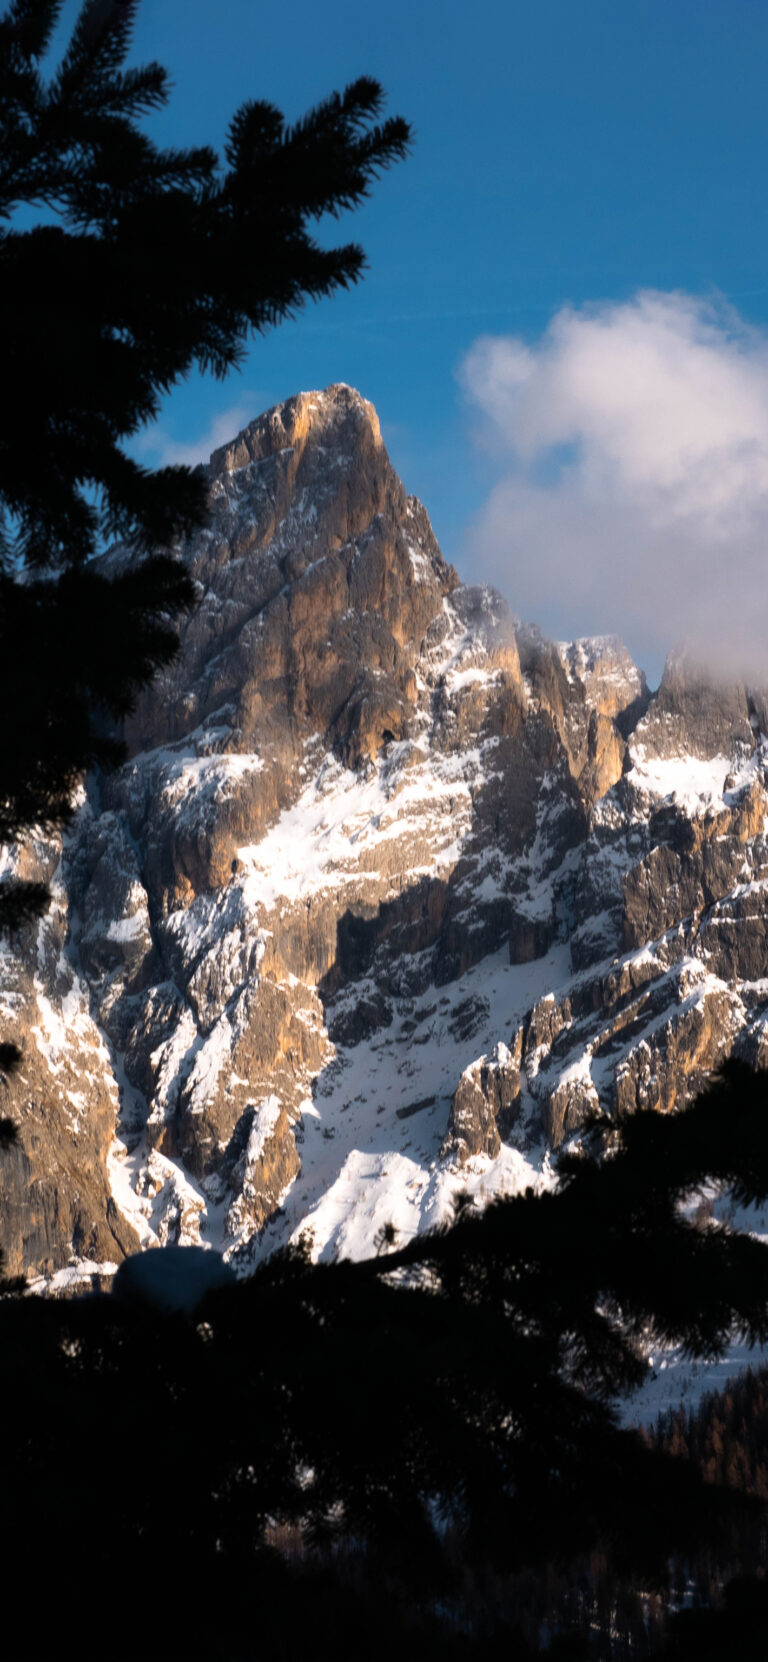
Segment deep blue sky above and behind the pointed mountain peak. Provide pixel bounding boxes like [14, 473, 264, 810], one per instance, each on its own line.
[43, 0, 768, 673]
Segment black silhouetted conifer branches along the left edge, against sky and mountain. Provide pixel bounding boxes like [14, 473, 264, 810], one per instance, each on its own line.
[0, 0, 411, 1156]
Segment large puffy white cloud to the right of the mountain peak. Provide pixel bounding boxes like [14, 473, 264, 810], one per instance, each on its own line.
[460, 293, 768, 680]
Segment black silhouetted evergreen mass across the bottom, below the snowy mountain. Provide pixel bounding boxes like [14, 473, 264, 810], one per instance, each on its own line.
[0, 1064, 768, 1659]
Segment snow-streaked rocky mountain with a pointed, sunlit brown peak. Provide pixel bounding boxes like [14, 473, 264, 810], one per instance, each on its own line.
[0, 387, 768, 1276]
